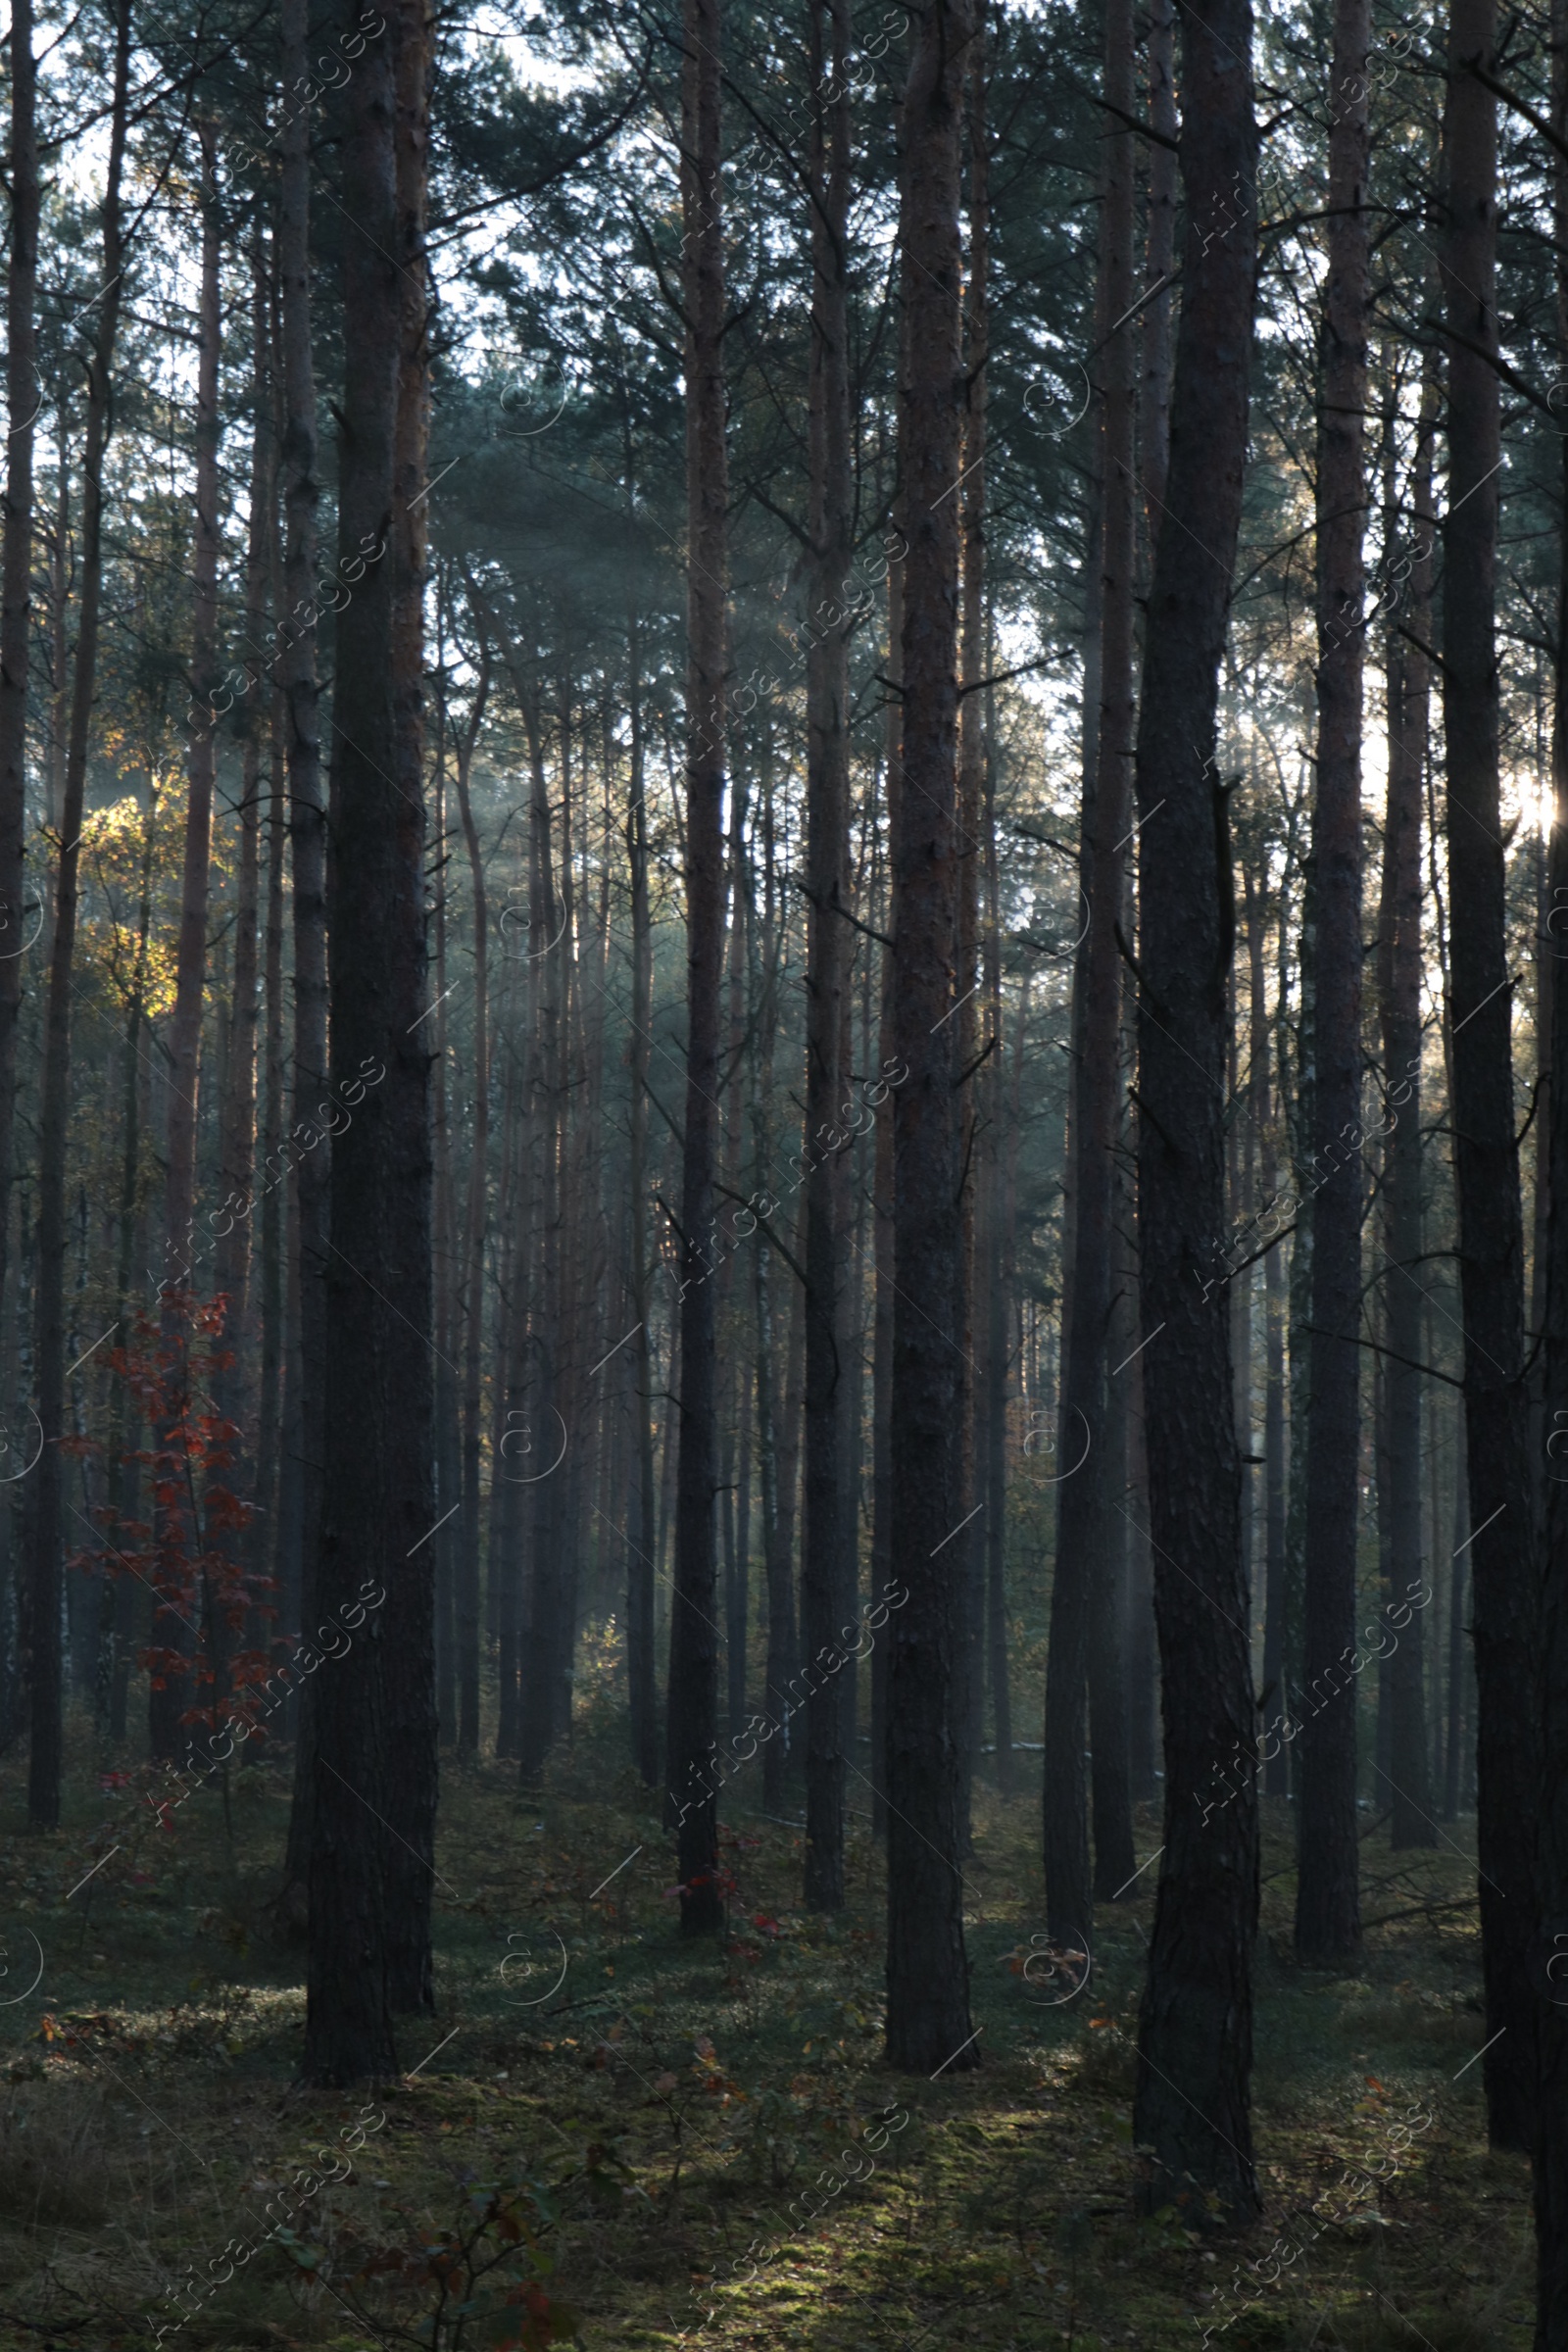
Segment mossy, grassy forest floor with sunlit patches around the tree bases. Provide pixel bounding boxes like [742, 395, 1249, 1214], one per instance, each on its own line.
[0, 1727, 1533, 2352]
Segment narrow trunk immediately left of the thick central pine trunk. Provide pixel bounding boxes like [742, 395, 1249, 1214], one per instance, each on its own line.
[800, 0, 851, 1910]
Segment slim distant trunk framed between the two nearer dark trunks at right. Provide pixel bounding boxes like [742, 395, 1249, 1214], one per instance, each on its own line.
[1378, 376, 1437, 1851]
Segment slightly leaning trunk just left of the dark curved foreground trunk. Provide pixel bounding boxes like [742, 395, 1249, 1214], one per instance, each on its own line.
[1044, 0, 1136, 1950]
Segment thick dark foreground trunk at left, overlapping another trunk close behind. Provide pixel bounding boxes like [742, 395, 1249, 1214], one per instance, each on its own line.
[303, 0, 430, 2083]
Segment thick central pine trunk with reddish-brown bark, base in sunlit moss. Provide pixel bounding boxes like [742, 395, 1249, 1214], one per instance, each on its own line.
[886, 0, 980, 2075]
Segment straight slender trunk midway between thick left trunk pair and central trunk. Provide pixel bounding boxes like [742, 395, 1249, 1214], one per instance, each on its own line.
[667, 0, 729, 1936]
